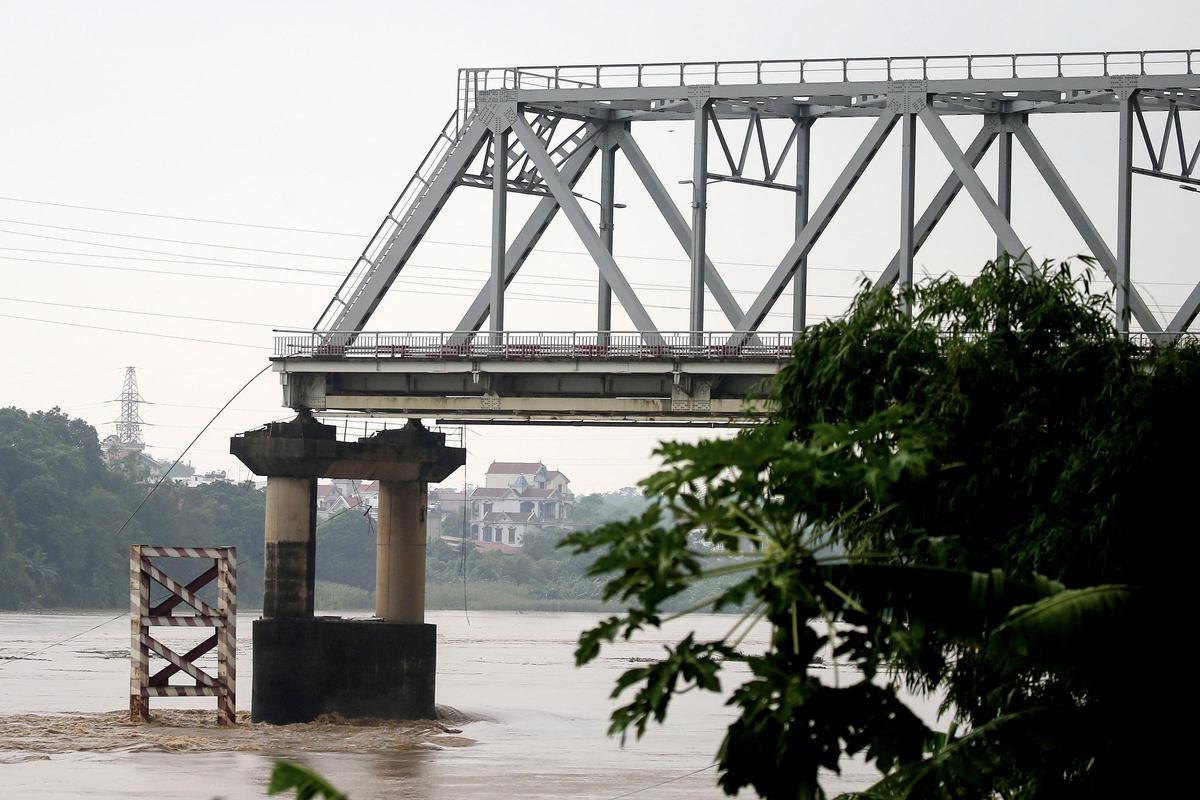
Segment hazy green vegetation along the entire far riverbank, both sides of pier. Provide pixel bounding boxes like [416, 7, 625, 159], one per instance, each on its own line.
[0, 408, 646, 612]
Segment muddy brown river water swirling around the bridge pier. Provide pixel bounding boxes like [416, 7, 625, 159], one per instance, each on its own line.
[0, 612, 902, 800]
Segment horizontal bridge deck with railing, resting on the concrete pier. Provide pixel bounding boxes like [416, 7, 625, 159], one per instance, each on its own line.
[272, 331, 794, 425]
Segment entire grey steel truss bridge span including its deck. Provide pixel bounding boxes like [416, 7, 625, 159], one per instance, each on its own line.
[272, 50, 1200, 425]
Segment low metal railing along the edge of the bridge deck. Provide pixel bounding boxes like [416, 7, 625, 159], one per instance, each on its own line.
[274, 331, 797, 361]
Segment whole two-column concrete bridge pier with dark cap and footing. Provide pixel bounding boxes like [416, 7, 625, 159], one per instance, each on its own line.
[229, 410, 466, 723]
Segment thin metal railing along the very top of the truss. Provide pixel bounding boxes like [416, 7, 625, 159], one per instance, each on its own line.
[458, 49, 1200, 104]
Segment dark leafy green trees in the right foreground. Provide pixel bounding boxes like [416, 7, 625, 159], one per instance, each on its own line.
[566, 260, 1200, 798]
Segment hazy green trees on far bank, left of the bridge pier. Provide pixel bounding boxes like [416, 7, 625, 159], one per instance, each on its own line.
[0, 408, 263, 608]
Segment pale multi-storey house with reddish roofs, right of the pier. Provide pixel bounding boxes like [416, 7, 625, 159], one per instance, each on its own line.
[467, 461, 575, 552]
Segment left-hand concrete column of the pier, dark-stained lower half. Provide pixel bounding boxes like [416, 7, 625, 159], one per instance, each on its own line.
[263, 475, 317, 619]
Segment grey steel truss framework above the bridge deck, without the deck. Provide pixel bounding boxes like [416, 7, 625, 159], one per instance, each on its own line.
[292, 50, 1200, 422]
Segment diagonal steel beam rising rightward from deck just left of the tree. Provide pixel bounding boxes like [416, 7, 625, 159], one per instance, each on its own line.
[731, 109, 898, 335]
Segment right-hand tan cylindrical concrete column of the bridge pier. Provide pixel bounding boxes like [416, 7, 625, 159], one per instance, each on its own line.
[376, 480, 428, 625]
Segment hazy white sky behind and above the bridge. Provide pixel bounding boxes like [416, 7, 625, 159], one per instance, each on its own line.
[0, 0, 1200, 492]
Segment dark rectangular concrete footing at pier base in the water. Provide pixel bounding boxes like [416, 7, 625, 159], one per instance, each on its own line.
[250, 616, 437, 724]
